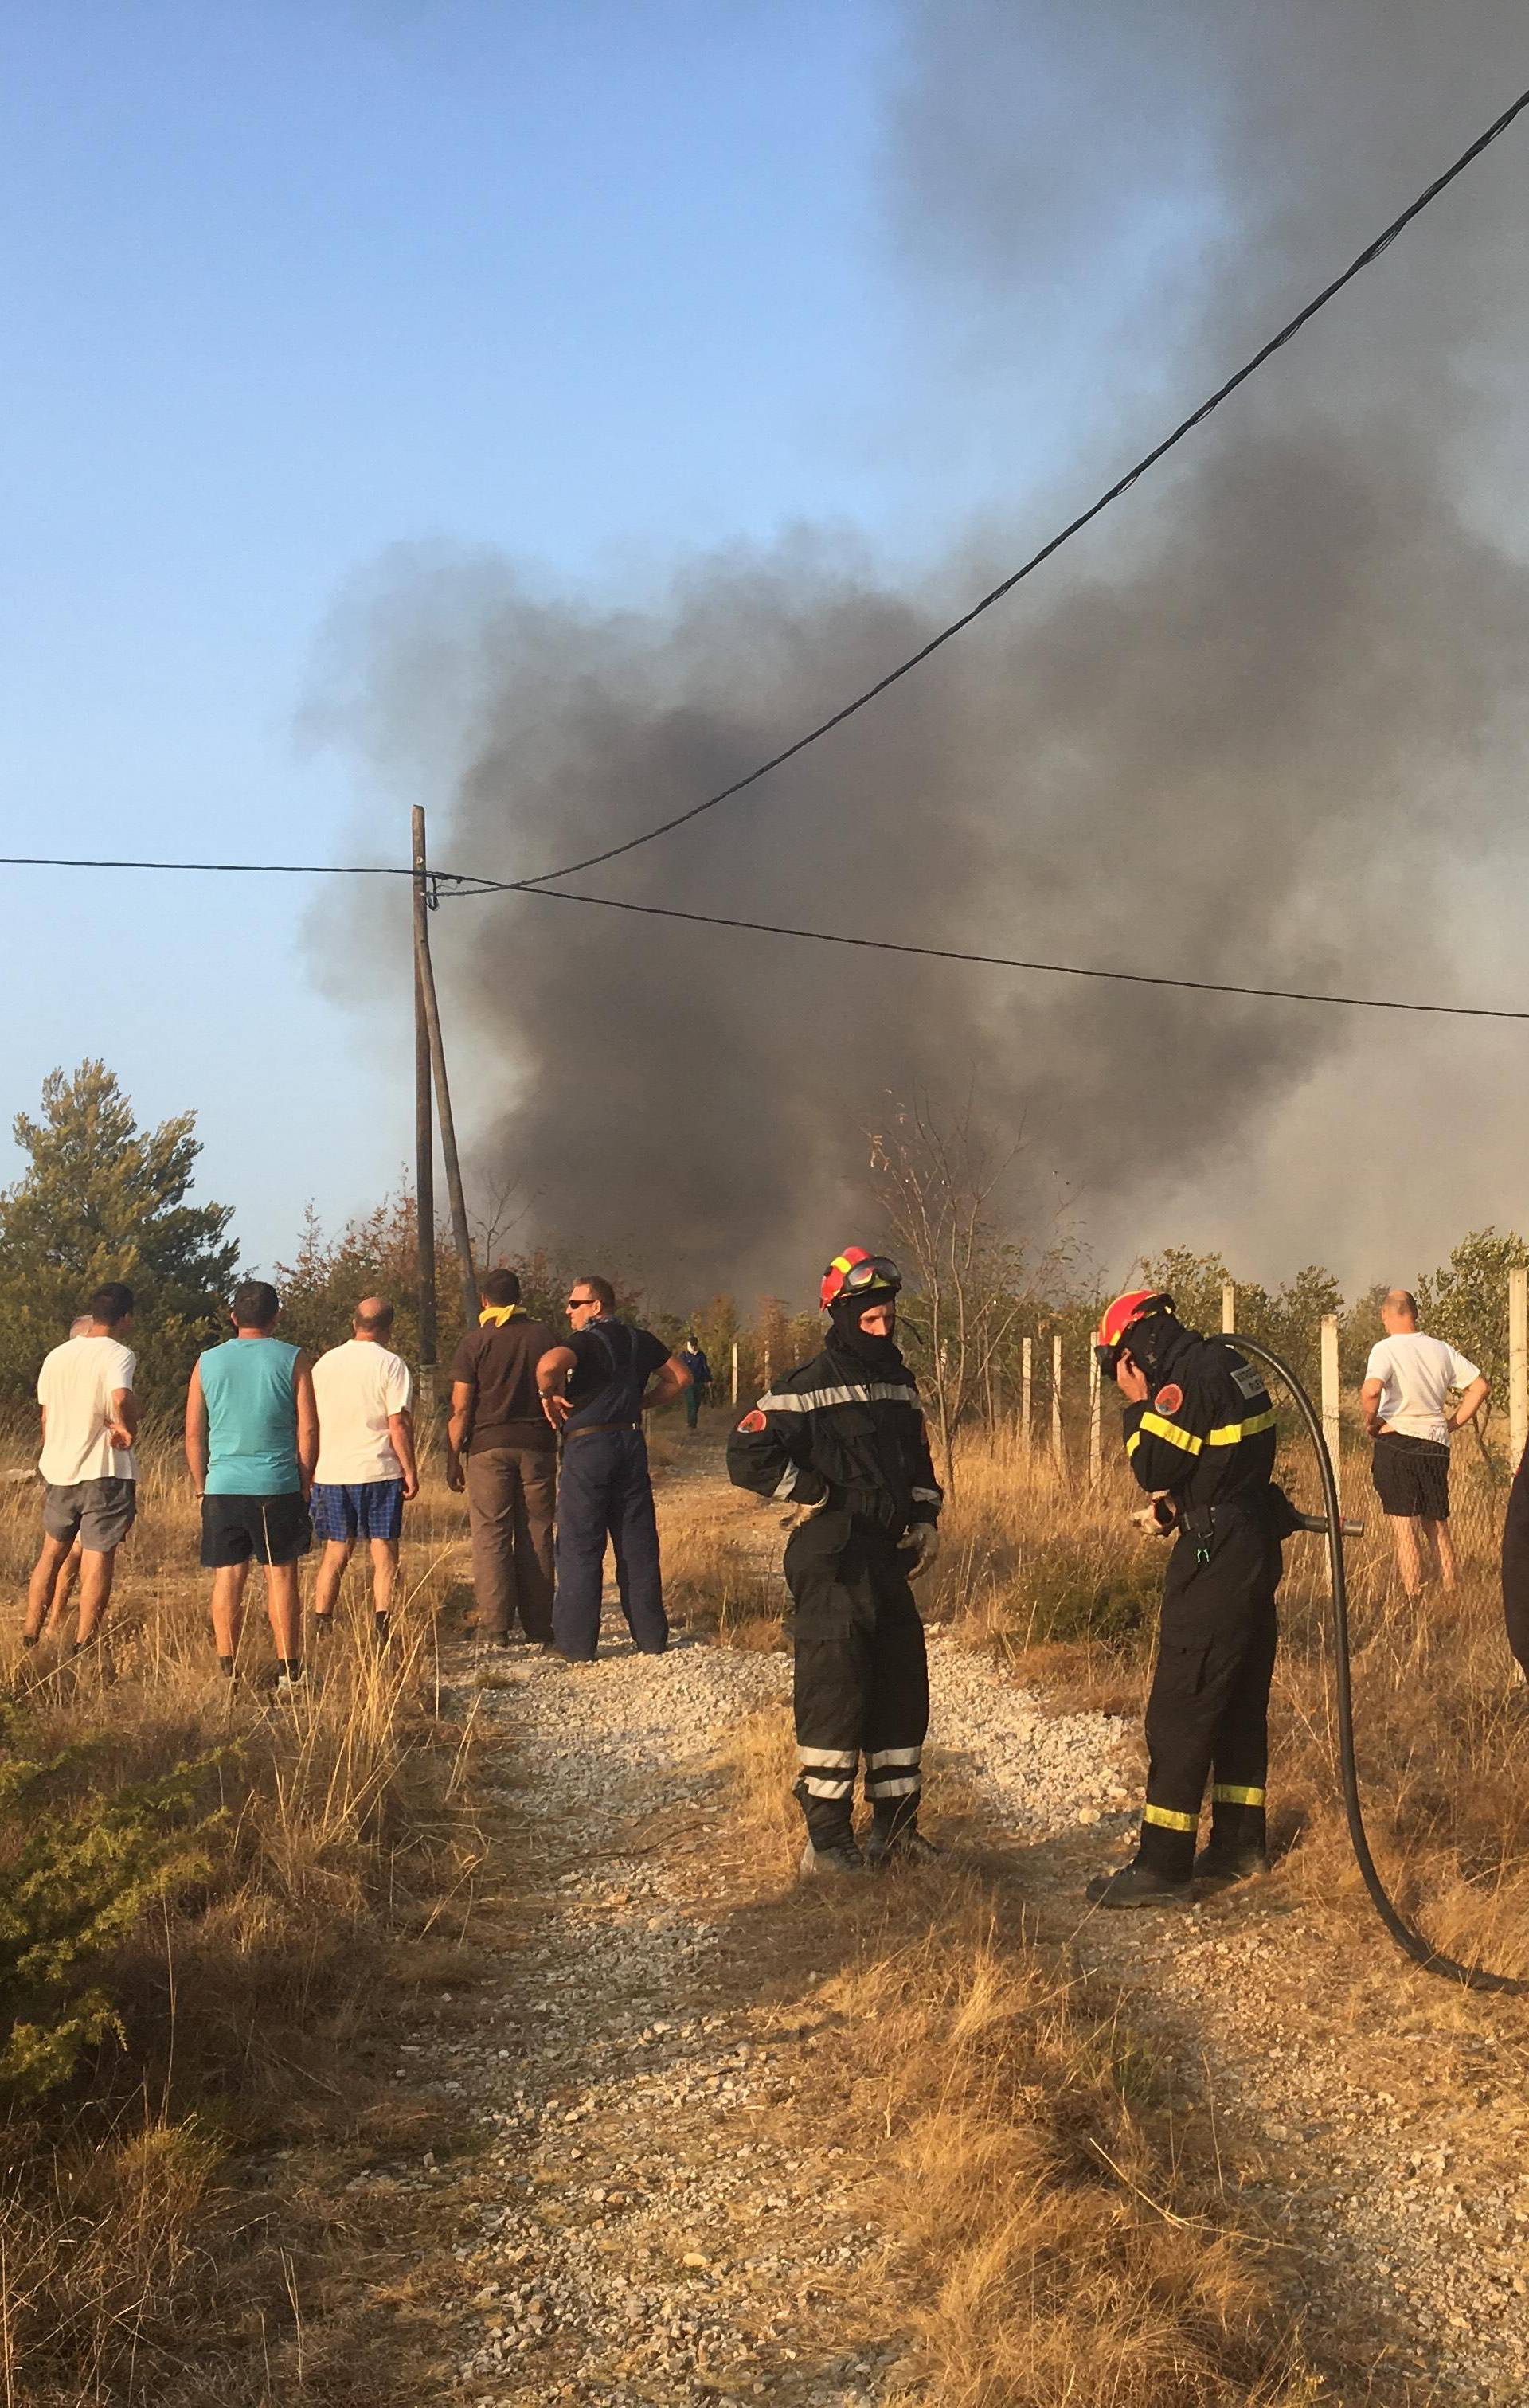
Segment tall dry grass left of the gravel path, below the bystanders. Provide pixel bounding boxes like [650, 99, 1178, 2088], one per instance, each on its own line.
[0, 1454, 477, 2408]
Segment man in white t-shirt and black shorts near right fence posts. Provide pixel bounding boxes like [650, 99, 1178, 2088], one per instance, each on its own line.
[1360, 1288, 1486, 1597]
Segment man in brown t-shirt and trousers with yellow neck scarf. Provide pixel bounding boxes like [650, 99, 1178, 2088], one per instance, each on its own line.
[445, 1272, 556, 1647]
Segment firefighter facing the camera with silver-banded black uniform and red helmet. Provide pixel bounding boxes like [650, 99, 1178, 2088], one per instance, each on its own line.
[727, 1245, 944, 1874]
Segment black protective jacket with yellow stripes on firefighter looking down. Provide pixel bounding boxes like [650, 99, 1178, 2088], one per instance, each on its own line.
[1124, 1312, 1277, 1510]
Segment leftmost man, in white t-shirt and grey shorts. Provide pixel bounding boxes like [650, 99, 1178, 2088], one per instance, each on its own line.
[22, 1279, 137, 1652]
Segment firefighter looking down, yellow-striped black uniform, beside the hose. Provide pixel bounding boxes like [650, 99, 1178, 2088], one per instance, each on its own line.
[1089, 1288, 1296, 1907]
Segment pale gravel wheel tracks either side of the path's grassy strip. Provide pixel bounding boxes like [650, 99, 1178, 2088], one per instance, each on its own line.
[362, 1444, 1529, 2408]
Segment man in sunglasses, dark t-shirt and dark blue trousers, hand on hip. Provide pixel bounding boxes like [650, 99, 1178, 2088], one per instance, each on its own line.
[537, 1279, 691, 1664]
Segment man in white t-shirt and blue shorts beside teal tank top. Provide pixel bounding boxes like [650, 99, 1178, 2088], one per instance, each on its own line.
[308, 1296, 419, 1642]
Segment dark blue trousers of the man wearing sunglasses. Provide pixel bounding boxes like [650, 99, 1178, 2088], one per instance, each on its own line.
[551, 1430, 670, 1659]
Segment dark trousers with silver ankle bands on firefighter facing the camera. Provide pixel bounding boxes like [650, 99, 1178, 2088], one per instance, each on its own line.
[785, 1512, 929, 1847]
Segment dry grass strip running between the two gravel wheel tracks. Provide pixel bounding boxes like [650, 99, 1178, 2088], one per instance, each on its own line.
[729, 1714, 1332, 2408]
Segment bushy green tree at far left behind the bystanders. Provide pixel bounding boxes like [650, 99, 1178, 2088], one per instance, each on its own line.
[0, 1062, 238, 1409]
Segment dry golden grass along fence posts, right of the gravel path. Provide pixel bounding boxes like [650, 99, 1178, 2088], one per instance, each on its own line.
[934, 1430, 1529, 1972]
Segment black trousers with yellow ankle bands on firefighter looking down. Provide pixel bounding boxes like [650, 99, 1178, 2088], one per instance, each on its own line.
[1141, 1507, 1281, 1881]
